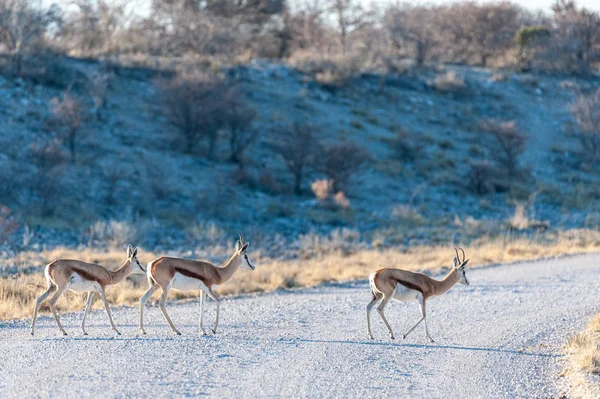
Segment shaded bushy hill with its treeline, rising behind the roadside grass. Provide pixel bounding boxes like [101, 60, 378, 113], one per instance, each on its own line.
[0, 0, 600, 282]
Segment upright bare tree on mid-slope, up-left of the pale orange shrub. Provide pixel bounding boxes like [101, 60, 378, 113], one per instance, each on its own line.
[273, 122, 319, 195]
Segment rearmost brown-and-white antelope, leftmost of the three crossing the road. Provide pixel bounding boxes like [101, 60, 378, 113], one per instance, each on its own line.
[31, 245, 146, 335]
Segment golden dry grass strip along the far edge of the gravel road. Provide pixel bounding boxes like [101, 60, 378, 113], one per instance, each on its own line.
[0, 230, 600, 319]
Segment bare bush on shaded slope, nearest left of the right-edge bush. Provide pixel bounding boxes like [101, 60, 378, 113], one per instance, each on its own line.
[480, 120, 527, 184]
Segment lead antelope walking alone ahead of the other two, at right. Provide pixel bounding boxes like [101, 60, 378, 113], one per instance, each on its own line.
[367, 248, 470, 342]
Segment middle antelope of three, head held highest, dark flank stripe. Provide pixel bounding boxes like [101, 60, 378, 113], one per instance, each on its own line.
[140, 232, 255, 335]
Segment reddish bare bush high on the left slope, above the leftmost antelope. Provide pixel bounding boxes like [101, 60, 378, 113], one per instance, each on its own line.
[52, 92, 85, 164]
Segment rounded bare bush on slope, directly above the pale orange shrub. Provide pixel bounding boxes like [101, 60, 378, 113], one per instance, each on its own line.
[314, 142, 369, 192]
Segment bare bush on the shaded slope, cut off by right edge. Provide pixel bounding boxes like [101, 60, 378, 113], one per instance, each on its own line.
[571, 89, 600, 166]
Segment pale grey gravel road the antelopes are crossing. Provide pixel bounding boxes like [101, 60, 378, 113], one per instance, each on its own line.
[0, 254, 600, 398]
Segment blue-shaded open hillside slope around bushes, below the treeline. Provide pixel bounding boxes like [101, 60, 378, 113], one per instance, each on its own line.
[0, 59, 600, 268]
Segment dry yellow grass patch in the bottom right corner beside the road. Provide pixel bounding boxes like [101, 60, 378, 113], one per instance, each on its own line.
[563, 314, 600, 398]
